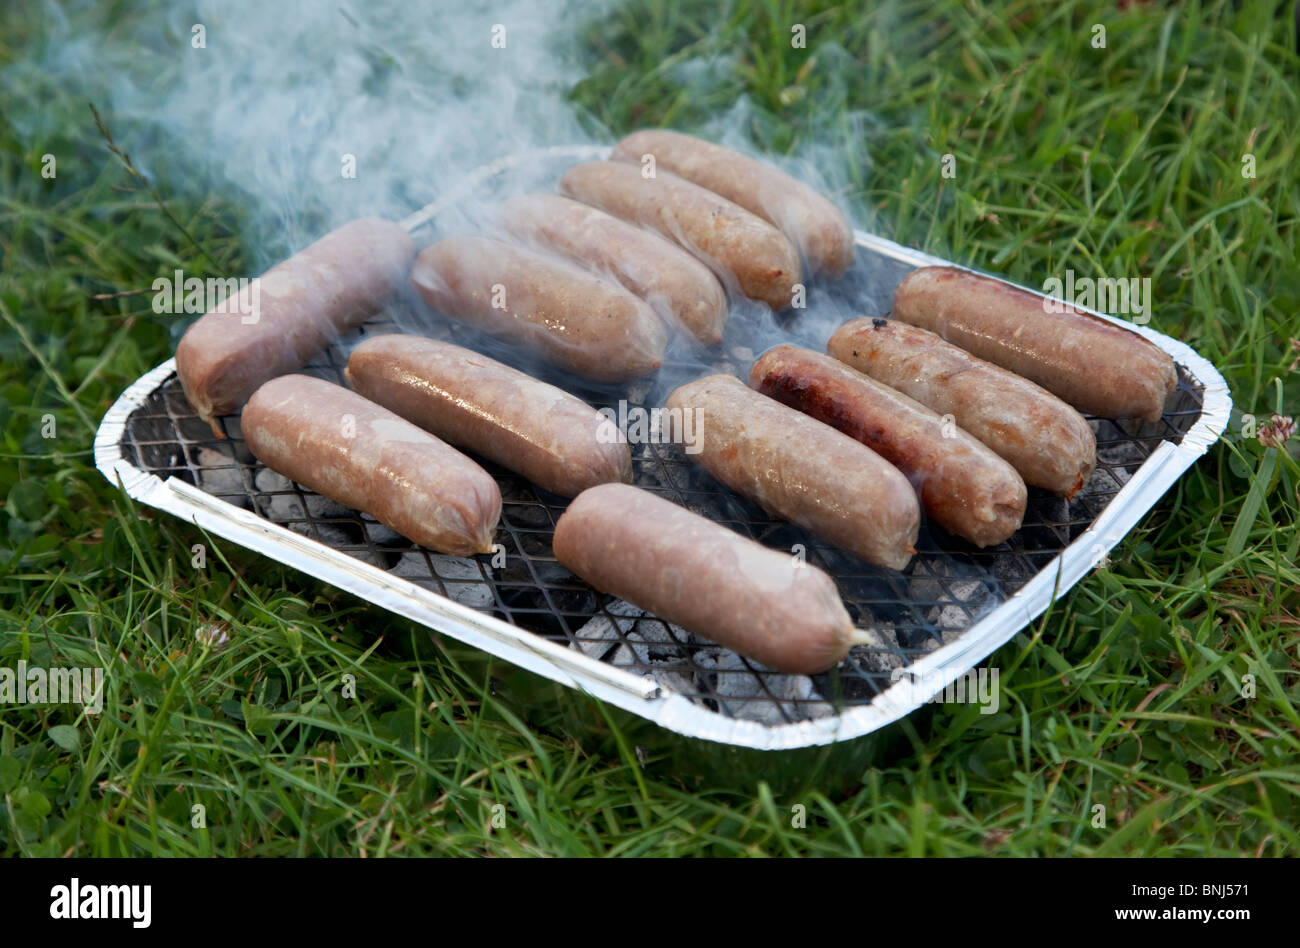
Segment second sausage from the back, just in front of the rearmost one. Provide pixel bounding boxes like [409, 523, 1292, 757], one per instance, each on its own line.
[560, 161, 802, 309]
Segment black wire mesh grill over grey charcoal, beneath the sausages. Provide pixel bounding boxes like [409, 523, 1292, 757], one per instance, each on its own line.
[122, 270, 1201, 724]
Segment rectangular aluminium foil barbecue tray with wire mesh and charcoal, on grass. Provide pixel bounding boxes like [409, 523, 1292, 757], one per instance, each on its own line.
[95, 146, 1231, 750]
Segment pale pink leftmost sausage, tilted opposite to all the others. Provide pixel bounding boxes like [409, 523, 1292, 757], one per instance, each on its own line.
[176, 217, 415, 437]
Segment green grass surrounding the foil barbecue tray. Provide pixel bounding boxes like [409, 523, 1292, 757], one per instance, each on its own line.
[0, 0, 1300, 856]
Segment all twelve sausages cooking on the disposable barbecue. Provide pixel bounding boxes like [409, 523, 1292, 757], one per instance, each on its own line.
[167, 131, 1175, 672]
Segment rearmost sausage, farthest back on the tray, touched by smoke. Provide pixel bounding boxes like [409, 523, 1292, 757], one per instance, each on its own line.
[614, 129, 853, 278]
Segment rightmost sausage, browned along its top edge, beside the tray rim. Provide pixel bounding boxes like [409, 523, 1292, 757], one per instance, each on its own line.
[893, 267, 1178, 421]
